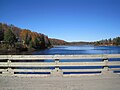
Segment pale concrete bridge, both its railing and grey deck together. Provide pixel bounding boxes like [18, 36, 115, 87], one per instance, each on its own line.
[0, 54, 120, 90]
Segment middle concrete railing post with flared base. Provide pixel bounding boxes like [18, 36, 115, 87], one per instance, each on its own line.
[51, 59, 63, 76]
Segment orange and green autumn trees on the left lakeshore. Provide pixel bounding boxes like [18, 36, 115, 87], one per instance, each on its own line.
[0, 23, 51, 50]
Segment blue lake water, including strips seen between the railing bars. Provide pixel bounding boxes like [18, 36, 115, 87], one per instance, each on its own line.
[16, 45, 120, 74]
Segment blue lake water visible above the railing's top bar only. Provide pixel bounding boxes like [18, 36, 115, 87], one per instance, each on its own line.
[33, 45, 120, 55]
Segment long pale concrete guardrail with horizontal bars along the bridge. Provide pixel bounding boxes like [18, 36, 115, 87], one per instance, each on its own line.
[0, 54, 120, 76]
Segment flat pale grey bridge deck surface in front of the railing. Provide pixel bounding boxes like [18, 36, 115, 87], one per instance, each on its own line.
[0, 75, 120, 90]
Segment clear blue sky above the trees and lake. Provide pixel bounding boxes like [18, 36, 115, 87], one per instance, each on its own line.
[0, 0, 120, 41]
